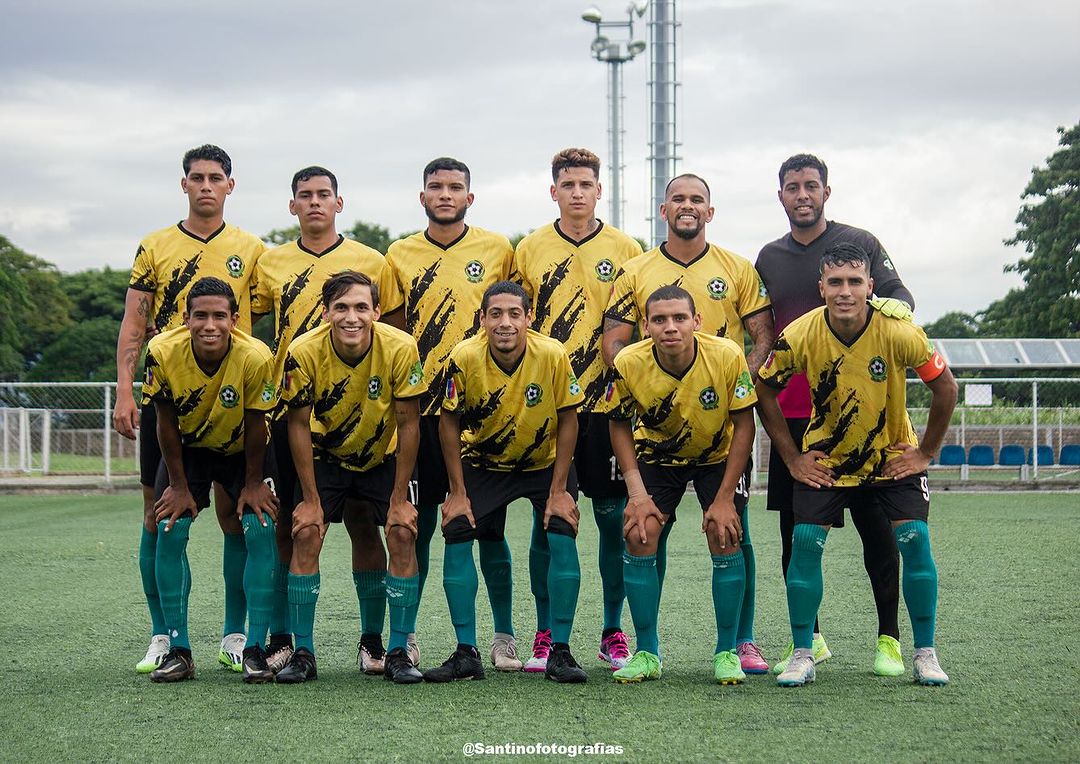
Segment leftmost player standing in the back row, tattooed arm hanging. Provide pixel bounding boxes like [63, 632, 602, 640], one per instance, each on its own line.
[112, 144, 266, 673]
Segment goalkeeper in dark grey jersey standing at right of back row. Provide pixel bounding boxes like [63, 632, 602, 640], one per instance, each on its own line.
[752, 153, 915, 675]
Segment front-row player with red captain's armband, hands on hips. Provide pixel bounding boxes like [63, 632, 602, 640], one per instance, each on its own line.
[757, 242, 957, 687]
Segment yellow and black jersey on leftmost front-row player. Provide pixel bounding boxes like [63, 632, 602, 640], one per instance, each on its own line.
[143, 326, 278, 454]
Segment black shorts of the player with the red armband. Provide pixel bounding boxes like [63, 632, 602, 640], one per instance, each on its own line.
[795, 472, 930, 525]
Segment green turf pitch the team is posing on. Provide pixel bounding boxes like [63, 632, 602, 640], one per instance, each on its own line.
[0, 493, 1080, 762]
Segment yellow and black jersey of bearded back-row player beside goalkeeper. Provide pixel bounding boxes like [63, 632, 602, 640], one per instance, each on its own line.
[606, 244, 769, 345]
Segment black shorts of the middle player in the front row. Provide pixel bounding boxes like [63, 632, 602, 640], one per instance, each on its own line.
[443, 465, 578, 544]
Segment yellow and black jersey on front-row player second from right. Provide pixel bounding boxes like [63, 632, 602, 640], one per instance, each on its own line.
[607, 332, 757, 467]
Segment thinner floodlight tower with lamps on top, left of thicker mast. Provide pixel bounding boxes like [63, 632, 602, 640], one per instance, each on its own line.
[581, 2, 647, 228]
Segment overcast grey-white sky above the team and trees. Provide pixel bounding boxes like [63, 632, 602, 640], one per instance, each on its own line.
[0, 0, 1080, 321]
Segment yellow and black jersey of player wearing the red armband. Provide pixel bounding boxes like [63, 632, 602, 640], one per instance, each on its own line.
[760, 307, 945, 487]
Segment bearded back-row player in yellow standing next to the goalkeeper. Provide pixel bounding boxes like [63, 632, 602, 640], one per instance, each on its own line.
[604, 174, 773, 673]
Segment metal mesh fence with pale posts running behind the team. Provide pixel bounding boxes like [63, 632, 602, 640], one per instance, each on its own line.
[0, 377, 1080, 485]
